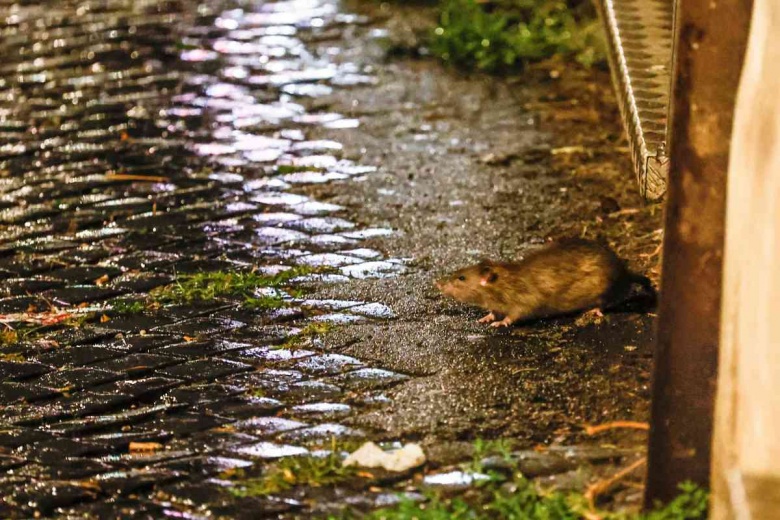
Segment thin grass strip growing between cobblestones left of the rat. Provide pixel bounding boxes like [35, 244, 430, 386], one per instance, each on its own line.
[151, 267, 315, 309]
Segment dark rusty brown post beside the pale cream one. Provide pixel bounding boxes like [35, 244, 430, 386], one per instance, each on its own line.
[645, 0, 751, 505]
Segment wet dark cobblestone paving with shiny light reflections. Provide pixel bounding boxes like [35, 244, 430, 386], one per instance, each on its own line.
[0, 0, 414, 518]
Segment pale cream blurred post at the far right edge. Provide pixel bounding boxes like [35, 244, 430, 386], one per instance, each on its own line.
[712, 0, 780, 520]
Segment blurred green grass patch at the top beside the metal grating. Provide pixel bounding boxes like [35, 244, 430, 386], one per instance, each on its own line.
[430, 0, 606, 73]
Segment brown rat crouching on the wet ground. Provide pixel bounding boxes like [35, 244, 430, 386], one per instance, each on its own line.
[436, 238, 655, 327]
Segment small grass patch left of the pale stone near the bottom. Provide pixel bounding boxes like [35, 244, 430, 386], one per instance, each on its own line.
[228, 442, 357, 497]
